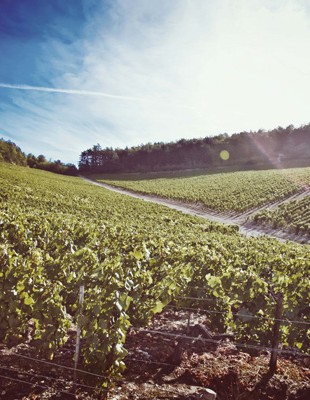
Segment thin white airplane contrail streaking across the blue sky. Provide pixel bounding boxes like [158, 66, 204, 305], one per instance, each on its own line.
[0, 83, 194, 110]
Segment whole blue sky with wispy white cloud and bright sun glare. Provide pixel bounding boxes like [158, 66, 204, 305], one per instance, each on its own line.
[0, 0, 310, 164]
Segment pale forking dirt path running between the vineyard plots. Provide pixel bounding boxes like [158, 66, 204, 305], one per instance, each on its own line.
[80, 176, 310, 244]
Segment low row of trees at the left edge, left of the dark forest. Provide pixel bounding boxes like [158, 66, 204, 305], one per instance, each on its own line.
[0, 139, 78, 175]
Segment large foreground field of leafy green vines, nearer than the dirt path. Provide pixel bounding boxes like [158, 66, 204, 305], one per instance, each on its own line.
[0, 164, 310, 385]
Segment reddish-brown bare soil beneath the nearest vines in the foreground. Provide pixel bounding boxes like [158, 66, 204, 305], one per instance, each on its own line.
[0, 309, 310, 400]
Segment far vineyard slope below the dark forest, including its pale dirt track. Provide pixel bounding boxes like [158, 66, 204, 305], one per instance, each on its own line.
[91, 168, 310, 243]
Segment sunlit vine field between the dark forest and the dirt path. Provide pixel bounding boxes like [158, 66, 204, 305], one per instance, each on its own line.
[95, 168, 310, 213]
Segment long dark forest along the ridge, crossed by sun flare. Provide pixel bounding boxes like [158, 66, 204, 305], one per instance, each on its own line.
[79, 124, 310, 173]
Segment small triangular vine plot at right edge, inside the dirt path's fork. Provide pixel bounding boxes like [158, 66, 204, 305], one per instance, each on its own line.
[252, 196, 310, 235]
